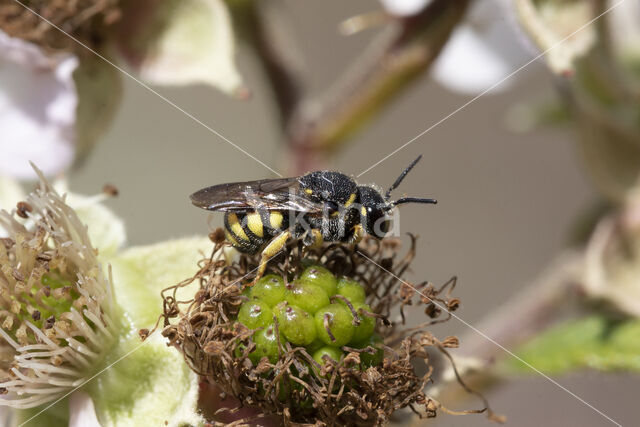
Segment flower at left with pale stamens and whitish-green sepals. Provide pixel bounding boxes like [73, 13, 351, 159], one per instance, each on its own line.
[0, 168, 211, 427]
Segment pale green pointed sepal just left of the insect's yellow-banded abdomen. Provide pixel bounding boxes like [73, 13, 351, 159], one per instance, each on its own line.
[107, 237, 213, 329]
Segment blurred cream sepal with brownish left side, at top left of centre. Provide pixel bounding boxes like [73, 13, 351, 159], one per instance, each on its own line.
[120, 0, 242, 93]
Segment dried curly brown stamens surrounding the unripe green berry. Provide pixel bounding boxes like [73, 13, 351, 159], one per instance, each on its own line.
[163, 237, 490, 425]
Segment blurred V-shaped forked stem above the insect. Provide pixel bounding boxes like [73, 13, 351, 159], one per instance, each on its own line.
[240, 0, 470, 174]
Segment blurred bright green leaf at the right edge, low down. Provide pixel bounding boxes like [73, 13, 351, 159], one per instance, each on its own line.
[505, 316, 640, 374]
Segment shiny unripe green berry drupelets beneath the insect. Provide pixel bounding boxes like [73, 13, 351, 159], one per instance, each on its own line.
[237, 265, 383, 367]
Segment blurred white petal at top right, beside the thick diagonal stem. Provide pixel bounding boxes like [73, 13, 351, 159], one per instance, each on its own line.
[431, 0, 533, 94]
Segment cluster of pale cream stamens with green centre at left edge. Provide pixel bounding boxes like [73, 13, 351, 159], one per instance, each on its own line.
[0, 167, 116, 408]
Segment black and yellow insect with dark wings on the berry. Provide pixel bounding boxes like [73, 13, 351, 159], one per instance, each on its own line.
[190, 156, 437, 283]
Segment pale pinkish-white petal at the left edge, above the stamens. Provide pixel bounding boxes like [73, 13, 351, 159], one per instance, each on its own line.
[0, 31, 78, 179]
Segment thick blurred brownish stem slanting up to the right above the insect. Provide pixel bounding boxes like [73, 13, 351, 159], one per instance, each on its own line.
[288, 0, 469, 158]
